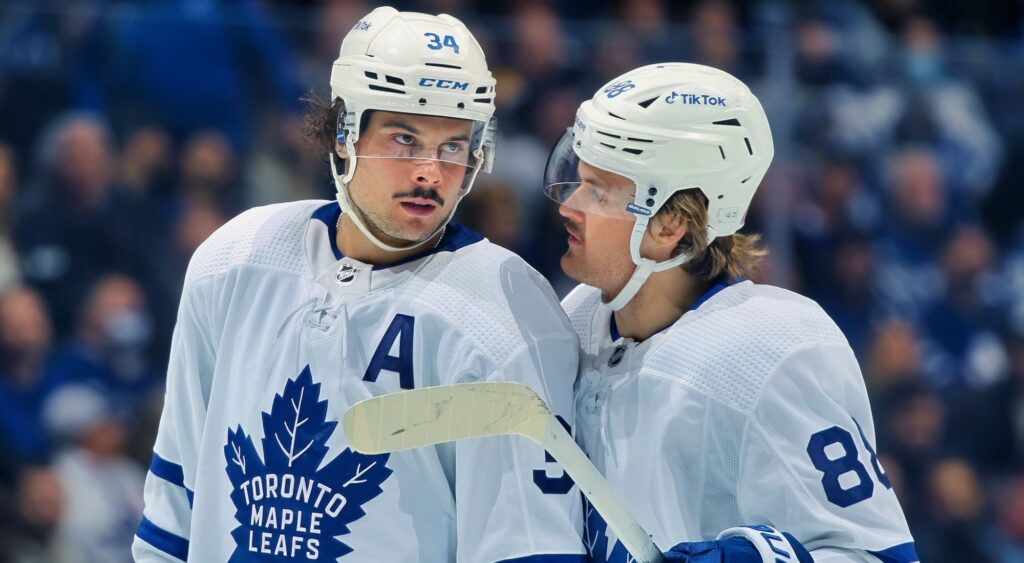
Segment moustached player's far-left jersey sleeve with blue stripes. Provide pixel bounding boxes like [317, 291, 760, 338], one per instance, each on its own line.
[132, 280, 215, 562]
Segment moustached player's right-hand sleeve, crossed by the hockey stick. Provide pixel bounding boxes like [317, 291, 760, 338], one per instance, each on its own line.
[456, 331, 584, 563]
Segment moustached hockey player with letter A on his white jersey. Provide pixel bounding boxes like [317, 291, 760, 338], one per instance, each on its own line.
[133, 7, 585, 563]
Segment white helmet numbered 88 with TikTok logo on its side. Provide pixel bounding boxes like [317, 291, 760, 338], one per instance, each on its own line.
[545, 62, 774, 309]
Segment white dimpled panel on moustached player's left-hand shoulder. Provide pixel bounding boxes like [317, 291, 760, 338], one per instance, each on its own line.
[185, 202, 313, 287]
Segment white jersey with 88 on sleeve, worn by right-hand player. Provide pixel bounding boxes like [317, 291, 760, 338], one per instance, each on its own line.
[562, 282, 916, 562]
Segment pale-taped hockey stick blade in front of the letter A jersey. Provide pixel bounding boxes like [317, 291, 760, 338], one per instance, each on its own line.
[342, 382, 551, 453]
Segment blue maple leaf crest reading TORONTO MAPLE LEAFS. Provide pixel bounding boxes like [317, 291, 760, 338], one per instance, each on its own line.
[224, 365, 391, 563]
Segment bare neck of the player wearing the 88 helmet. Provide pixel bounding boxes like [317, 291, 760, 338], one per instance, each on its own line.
[615, 268, 708, 342]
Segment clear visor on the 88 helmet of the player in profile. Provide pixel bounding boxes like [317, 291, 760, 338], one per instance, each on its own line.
[544, 129, 636, 221]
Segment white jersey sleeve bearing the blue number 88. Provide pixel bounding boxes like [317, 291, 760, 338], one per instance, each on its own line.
[737, 344, 918, 563]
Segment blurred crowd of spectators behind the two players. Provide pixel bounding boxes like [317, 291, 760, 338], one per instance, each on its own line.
[0, 0, 1024, 563]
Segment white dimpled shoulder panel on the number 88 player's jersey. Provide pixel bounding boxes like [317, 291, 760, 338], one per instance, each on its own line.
[644, 282, 846, 415]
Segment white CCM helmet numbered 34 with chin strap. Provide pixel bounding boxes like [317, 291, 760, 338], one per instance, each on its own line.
[330, 6, 495, 252]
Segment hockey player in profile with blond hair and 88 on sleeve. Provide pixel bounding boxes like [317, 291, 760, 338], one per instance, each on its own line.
[546, 63, 916, 563]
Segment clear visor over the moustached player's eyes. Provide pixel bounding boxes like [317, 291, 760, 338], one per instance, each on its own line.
[344, 114, 495, 189]
